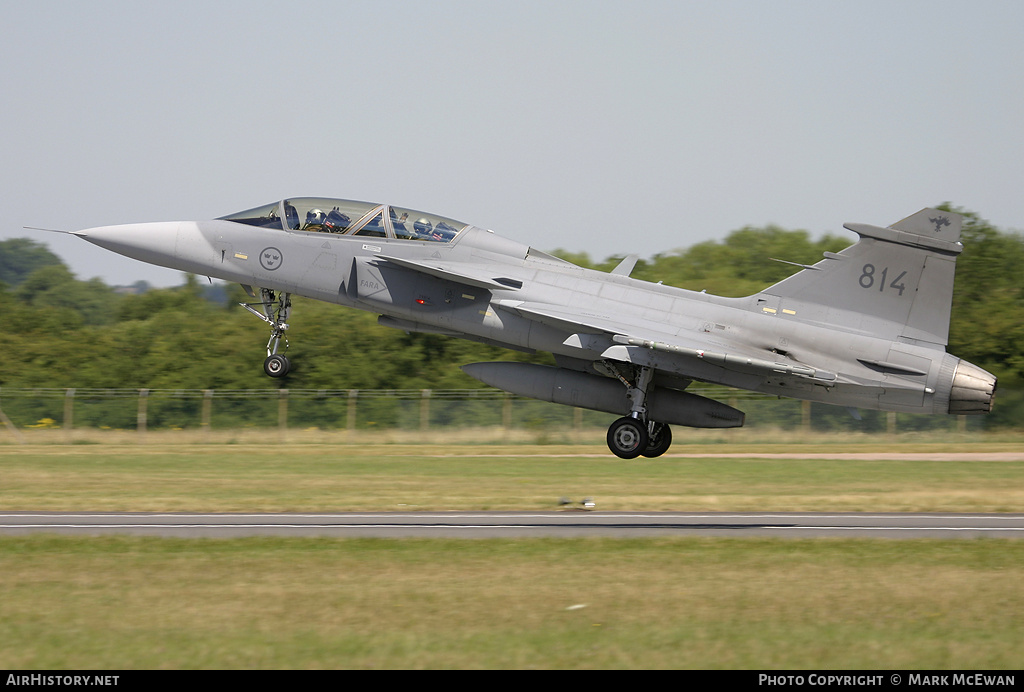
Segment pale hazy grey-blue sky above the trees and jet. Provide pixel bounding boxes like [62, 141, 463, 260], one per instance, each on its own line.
[0, 0, 1024, 286]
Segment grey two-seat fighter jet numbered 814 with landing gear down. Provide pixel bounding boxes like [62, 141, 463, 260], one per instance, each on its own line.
[75, 198, 995, 459]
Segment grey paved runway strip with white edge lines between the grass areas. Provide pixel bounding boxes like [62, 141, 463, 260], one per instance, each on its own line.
[0, 511, 1024, 538]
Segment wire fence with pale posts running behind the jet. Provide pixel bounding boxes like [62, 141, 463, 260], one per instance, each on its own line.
[0, 385, 985, 433]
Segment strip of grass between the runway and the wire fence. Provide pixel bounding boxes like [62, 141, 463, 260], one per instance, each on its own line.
[0, 437, 1024, 512]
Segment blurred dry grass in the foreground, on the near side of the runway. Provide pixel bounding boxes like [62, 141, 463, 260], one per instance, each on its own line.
[0, 536, 1024, 668]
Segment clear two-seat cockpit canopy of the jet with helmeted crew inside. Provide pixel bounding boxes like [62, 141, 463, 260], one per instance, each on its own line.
[220, 197, 469, 243]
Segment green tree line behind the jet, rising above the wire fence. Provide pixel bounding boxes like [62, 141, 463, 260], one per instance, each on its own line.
[0, 205, 1024, 426]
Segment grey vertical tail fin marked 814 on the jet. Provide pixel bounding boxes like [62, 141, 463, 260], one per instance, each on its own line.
[763, 209, 964, 346]
